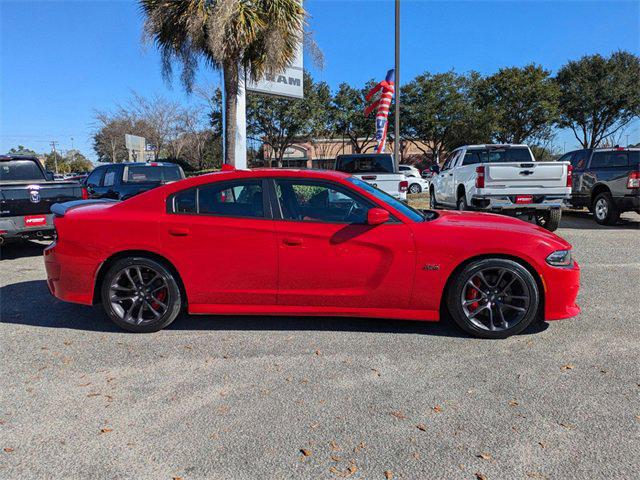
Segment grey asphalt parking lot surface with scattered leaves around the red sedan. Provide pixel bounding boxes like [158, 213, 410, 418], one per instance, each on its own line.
[0, 208, 640, 480]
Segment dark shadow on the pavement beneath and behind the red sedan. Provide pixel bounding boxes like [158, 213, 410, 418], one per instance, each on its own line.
[0, 280, 548, 337]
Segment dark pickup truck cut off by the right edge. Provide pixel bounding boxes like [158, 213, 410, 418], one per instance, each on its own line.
[560, 147, 640, 225]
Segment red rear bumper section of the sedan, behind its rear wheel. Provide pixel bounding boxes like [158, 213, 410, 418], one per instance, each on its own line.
[44, 242, 99, 305]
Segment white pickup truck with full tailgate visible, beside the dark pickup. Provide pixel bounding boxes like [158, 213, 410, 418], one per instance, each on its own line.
[429, 144, 571, 231]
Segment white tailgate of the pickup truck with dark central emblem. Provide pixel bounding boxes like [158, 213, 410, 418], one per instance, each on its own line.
[484, 162, 569, 189]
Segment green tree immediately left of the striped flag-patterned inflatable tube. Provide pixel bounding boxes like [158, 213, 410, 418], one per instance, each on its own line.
[333, 80, 376, 153]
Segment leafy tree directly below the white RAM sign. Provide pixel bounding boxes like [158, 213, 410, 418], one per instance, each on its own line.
[247, 72, 315, 167]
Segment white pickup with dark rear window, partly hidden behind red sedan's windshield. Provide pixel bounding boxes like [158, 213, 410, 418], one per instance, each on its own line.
[335, 153, 409, 200]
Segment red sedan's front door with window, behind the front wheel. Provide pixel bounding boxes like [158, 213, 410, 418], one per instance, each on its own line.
[271, 178, 415, 308]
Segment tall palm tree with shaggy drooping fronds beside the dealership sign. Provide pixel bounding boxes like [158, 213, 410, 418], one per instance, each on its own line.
[140, 0, 306, 165]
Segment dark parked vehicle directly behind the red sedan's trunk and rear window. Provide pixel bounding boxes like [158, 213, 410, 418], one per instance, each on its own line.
[85, 162, 185, 200]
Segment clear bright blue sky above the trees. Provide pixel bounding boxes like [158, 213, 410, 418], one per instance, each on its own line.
[0, 0, 640, 158]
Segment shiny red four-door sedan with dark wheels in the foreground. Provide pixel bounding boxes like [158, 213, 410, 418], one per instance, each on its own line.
[44, 170, 580, 338]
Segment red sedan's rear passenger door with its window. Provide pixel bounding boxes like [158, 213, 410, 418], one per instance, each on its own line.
[161, 178, 278, 313]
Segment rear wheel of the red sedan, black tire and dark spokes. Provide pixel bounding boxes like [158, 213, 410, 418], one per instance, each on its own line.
[100, 257, 182, 333]
